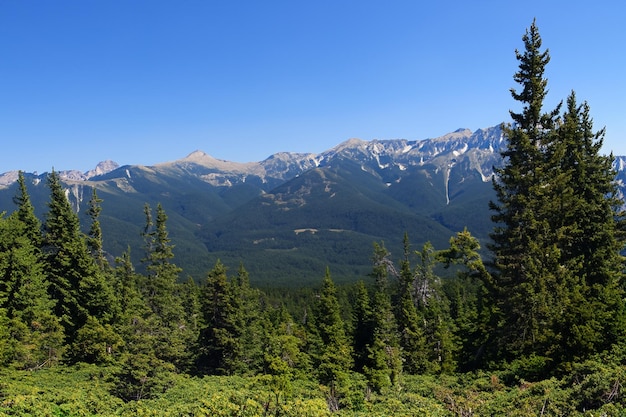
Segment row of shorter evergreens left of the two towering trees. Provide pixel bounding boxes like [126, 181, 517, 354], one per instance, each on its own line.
[0, 167, 488, 402]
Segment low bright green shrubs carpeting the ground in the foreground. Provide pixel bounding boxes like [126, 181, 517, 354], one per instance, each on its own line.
[0, 358, 626, 417]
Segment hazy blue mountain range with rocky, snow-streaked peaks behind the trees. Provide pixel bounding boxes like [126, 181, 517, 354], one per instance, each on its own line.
[0, 126, 626, 286]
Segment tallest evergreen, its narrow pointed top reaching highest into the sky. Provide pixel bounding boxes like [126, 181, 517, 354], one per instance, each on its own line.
[490, 22, 560, 364]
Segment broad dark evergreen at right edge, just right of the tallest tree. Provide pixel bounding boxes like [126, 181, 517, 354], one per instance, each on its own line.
[547, 92, 626, 364]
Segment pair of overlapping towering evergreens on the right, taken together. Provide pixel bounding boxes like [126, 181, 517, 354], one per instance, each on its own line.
[486, 22, 624, 377]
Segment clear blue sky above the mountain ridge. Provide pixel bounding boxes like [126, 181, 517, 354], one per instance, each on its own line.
[0, 0, 626, 172]
